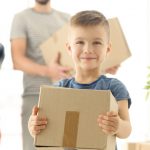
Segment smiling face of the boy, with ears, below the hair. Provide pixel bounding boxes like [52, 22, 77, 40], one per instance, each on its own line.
[67, 25, 110, 70]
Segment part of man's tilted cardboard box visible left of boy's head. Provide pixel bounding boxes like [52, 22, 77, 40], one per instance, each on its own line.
[40, 24, 73, 67]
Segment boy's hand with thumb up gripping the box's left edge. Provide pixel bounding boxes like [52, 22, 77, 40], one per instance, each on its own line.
[28, 106, 47, 137]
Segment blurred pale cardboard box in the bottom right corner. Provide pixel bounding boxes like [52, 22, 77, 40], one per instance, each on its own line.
[127, 142, 150, 150]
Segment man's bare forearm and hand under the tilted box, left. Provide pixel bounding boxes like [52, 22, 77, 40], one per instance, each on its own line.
[11, 38, 70, 80]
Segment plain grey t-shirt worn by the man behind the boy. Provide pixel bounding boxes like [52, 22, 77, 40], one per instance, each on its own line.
[10, 8, 70, 96]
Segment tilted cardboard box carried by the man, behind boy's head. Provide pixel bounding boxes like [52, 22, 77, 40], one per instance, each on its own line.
[40, 18, 131, 71]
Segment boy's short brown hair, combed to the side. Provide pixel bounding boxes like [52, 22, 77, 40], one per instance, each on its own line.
[70, 10, 110, 37]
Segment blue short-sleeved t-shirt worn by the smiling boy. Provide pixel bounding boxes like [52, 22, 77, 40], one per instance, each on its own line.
[56, 75, 131, 107]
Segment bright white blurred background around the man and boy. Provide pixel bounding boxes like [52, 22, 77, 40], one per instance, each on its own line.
[0, 0, 150, 150]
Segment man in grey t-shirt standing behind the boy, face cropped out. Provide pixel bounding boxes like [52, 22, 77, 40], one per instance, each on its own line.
[10, 0, 71, 150]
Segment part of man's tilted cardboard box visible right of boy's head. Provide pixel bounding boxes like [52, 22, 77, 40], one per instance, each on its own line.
[102, 18, 131, 71]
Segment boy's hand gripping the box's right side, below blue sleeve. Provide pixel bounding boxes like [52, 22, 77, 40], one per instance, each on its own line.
[97, 111, 120, 135]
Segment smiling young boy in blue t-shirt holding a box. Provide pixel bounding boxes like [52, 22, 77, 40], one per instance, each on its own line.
[28, 11, 131, 149]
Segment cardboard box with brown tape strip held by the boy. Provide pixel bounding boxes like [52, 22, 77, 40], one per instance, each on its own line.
[35, 86, 118, 150]
